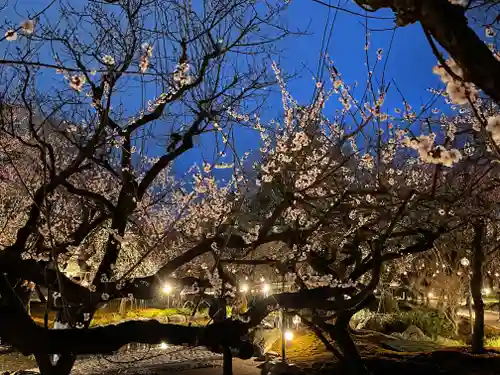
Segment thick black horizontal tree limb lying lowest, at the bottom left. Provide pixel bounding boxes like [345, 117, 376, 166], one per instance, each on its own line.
[0, 307, 253, 358]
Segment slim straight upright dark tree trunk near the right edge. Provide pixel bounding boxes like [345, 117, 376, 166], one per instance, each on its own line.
[470, 223, 484, 353]
